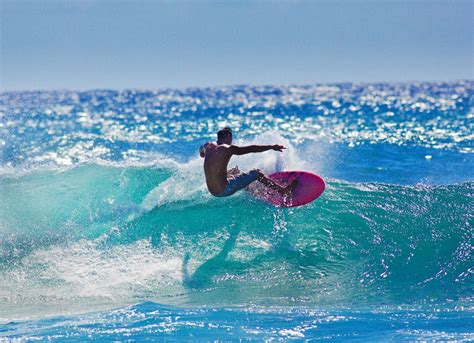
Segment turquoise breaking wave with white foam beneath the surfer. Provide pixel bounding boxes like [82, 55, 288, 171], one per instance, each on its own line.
[0, 163, 474, 318]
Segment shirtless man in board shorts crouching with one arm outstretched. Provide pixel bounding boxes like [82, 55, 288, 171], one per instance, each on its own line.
[199, 127, 296, 197]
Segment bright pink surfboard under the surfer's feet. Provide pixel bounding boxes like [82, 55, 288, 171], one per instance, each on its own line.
[248, 171, 326, 207]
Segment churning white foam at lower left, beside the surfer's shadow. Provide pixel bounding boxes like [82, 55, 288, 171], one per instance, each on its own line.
[0, 236, 183, 320]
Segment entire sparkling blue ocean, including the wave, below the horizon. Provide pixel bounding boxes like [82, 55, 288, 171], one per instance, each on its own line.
[0, 80, 474, 342]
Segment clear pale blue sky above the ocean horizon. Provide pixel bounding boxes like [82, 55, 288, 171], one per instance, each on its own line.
[0, 0, 473, 90]
